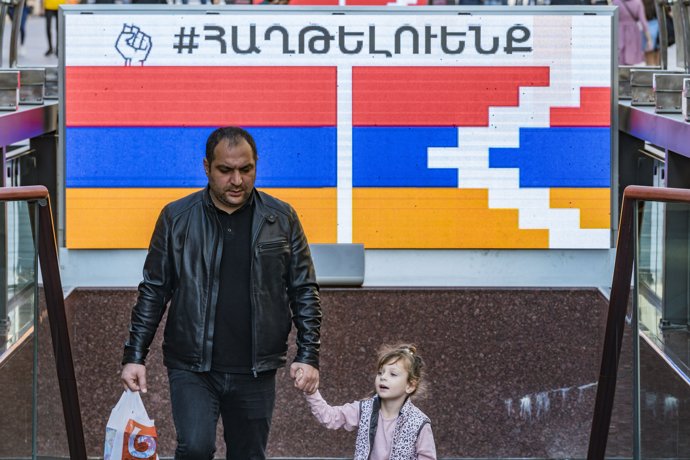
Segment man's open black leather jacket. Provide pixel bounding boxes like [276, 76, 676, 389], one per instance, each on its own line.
[123, 187, 321, 373]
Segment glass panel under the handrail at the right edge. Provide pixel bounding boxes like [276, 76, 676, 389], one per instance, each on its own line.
[636, 202, 690, 458]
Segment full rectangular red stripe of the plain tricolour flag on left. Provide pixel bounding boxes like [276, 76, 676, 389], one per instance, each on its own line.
[65, 66, 337, 126]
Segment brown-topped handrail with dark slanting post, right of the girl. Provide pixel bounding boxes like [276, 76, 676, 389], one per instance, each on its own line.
[587, 185, 690, 460]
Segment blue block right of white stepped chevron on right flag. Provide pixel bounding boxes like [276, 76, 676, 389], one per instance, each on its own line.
[489, 128, 611, 187]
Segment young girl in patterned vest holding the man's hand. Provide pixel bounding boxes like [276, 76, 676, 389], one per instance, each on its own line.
[297, 345, 436, 460]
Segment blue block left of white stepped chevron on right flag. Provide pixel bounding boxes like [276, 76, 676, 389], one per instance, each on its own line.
[352, 127, 458, 187]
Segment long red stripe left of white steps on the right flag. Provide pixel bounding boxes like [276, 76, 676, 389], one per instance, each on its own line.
[352, 67, 549, 126]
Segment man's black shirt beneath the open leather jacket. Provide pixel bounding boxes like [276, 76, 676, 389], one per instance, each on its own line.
[211, 195, 254, 374]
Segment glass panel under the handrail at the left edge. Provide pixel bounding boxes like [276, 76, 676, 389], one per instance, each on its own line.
[0, 202, 37, 458]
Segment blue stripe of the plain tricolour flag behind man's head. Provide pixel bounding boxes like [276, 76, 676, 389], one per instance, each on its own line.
[65, 127, 337, 188]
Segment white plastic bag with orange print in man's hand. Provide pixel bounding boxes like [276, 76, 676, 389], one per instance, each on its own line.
[103, 390, 158, 460]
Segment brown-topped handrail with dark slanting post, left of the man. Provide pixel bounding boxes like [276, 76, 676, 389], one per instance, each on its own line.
[0, 185, 86, 460]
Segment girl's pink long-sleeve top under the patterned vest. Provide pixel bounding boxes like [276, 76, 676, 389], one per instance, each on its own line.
[305, 391, 436, 460]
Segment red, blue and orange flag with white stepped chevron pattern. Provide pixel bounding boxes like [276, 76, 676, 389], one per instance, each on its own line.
[344, 67, 610, 248]
